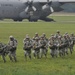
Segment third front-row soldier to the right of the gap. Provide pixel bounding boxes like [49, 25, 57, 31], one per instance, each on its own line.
[40, 36, 47, 58]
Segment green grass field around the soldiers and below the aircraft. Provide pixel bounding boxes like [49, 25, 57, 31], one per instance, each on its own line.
[0, 16, 75, 75]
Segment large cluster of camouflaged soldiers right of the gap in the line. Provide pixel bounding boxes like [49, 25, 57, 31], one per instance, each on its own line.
[23, 30, 75, 59]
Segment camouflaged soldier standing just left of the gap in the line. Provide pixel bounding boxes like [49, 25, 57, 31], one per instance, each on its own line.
[8, 36, 18, 62]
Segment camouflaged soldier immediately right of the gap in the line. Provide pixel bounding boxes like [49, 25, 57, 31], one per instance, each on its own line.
[23, 35, 32, 59]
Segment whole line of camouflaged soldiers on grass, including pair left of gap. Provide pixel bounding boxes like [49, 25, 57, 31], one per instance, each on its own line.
[0, 31, 75, 62]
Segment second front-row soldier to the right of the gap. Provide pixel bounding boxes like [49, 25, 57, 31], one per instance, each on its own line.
[33, 37, 40, 59]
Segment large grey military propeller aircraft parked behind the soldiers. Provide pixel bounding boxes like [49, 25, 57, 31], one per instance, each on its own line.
[0, 0, 75, 21]
